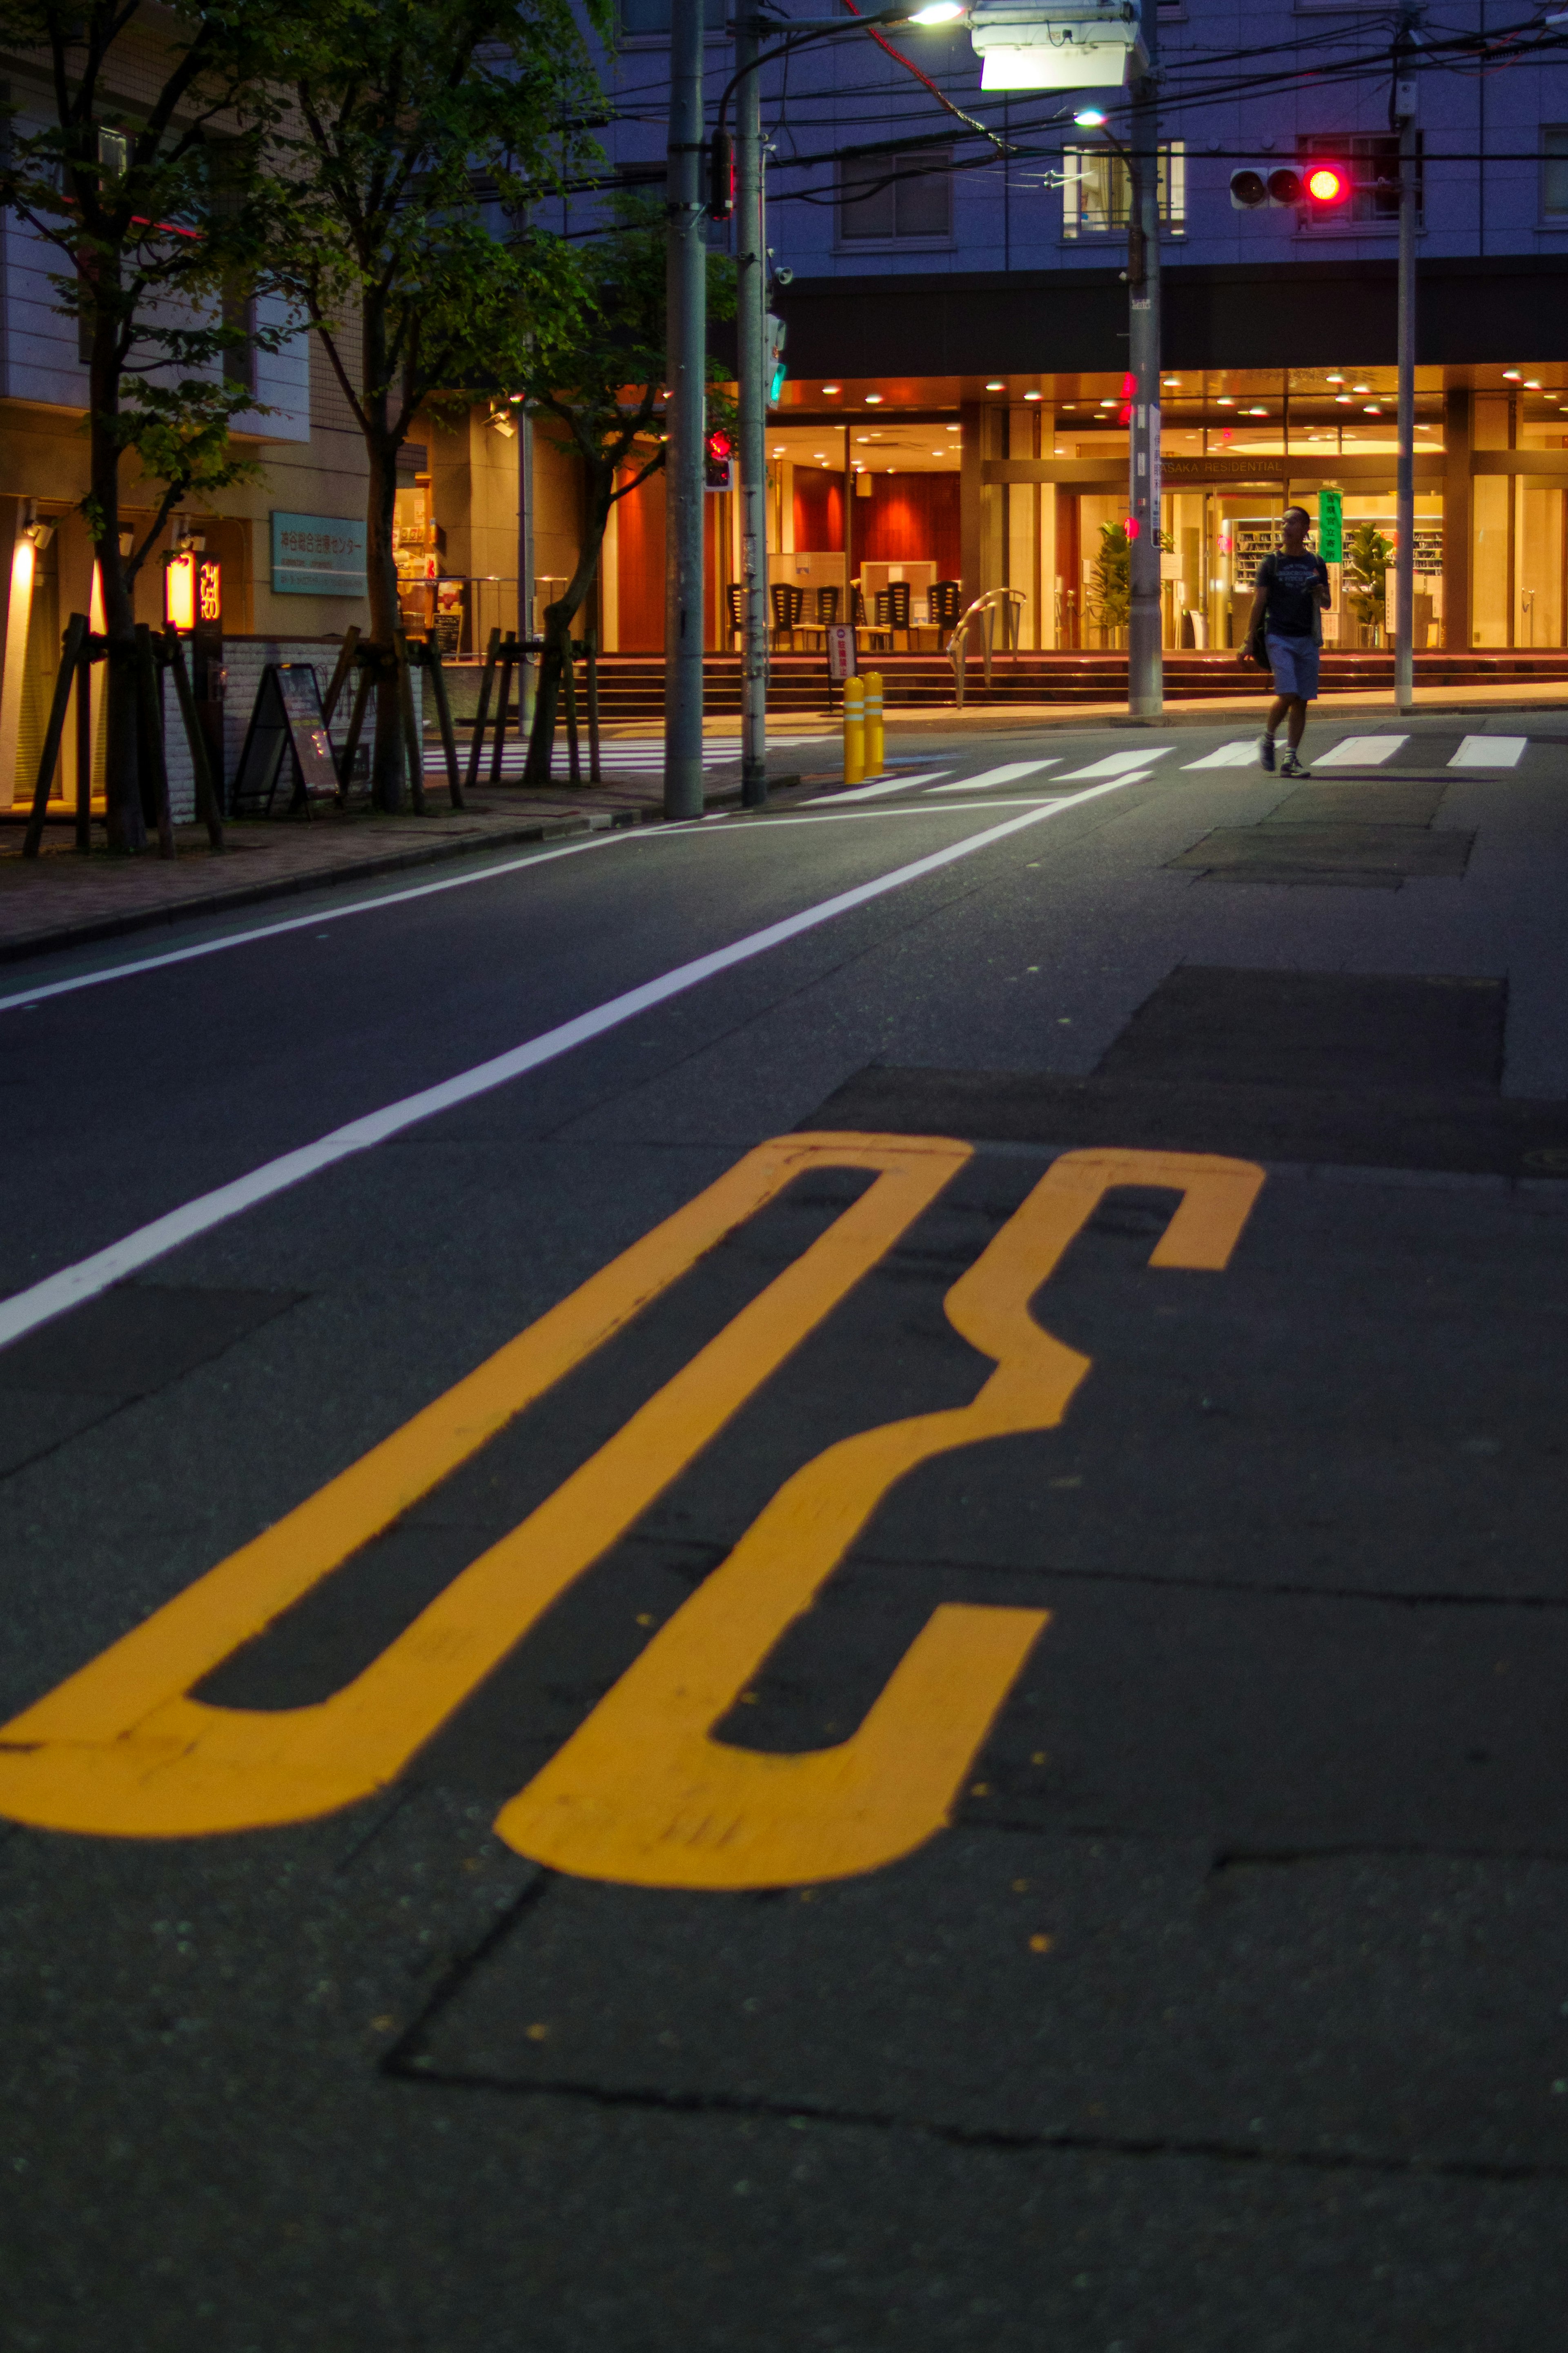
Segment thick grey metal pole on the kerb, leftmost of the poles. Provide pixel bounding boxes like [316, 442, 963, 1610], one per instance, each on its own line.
[665, 0, 708, 816]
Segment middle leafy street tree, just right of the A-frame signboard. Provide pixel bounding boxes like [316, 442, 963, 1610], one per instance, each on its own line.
[280, 0, 604, 810]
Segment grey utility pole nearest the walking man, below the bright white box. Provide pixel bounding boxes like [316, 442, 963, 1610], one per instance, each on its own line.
[1126, 0, 1166, 720]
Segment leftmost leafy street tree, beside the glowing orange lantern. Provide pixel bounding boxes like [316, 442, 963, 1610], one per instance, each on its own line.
[0, 0, 287, 850]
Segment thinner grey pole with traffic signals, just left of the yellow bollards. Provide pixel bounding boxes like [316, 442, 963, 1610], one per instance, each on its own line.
[736, 0, 769, 810]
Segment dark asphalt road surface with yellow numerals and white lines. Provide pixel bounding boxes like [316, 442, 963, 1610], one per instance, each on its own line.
[0, 713, 1568, 2353]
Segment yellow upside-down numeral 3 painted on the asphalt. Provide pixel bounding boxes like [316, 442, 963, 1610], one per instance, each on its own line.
[496, 1151, 1263, 1889]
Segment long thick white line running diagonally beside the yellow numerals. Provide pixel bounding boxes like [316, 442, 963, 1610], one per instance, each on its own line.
[0, 776, 1142, 1348]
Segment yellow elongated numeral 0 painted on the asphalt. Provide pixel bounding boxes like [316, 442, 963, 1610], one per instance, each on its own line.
[0, 1137, 969, 1838]
